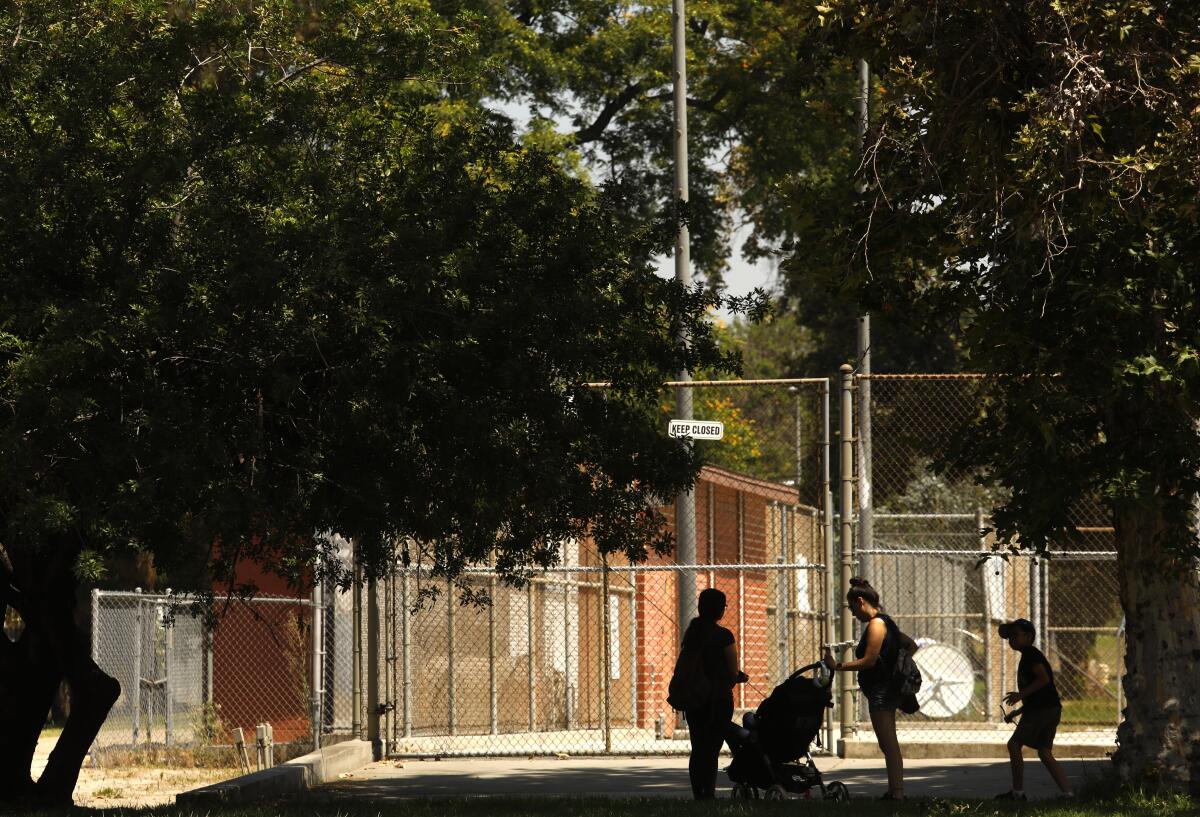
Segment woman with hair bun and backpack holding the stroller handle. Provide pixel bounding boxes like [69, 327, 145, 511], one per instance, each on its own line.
[823, 576, 917, 800]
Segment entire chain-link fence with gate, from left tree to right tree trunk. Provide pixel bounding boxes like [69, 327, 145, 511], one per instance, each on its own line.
[92, 376, 1123, 756]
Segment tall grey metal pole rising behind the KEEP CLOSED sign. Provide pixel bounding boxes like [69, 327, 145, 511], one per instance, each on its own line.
[671, 0, 696, 637]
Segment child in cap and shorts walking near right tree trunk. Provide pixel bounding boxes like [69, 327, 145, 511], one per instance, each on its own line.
[996, 618, 1073, 800]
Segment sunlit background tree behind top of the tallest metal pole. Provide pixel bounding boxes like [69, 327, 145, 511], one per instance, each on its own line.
[432, 0, 857, 284]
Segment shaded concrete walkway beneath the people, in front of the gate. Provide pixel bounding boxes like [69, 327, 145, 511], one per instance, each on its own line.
[319, 757, 1109, 800]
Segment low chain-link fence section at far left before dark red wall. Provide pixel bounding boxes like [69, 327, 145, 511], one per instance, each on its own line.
[91, 590, 353, 765]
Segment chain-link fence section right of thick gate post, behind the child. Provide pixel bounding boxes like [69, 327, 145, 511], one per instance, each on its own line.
[854, 374, 1123, 744]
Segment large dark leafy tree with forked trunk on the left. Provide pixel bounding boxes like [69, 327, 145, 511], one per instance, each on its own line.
[0, 0, 736, 803]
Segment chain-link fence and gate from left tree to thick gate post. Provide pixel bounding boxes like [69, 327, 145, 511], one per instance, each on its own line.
[92, 379, 833, 756]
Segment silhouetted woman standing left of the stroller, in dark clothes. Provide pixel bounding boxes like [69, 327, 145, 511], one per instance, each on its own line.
[672, 588, 749, 800]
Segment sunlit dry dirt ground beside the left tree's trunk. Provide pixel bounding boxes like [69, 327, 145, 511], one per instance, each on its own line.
[32, 734, 240, 809]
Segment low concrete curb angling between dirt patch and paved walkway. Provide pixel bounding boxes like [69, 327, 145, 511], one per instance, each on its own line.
[175, 740, 373, 807]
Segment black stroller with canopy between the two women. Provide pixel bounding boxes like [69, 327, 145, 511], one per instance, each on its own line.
[725, 662, 850, 803]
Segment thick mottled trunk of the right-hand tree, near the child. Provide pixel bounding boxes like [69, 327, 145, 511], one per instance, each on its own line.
[1112, 503, 1200, 794]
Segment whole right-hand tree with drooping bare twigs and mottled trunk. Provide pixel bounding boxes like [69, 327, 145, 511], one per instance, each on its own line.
[809, 0, 1200, 793]
